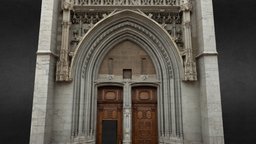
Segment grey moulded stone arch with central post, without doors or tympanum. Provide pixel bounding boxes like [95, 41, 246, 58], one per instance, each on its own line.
[70, 10, 183, 144]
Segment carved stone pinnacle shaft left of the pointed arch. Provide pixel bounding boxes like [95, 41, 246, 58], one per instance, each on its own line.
[56, 1, 73, 81]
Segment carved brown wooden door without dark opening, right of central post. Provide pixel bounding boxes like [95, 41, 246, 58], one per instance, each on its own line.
[132, 87, 158, 144]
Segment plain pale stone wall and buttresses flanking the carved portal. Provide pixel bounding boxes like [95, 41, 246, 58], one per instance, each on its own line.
[30, 0, 224, 144]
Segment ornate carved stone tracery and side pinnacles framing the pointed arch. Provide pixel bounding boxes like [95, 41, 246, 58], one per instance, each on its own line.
[56, 0, 197, 81]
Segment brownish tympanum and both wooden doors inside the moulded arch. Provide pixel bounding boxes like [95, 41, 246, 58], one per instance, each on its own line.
[97, 40, 158, 144]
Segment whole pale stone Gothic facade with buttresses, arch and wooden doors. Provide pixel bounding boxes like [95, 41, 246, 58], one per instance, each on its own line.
[30, 0, 224, 144]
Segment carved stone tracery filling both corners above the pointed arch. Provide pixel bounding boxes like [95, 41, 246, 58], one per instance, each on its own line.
[70, 12, 184, 53]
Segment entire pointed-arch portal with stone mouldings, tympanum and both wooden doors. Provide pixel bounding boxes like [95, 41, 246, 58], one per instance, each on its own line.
[71, 10, 183, 144]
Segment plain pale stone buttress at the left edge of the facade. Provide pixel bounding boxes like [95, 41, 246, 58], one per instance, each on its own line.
[30, 0, 58, 144]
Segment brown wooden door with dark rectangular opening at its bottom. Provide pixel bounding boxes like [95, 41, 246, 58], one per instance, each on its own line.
[96, 87, 123, 144]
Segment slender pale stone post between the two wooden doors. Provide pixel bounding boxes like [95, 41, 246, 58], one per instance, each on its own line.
[123, 81, 132, 144]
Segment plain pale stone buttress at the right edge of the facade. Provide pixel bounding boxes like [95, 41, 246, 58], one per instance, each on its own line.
[196, 0, 224, 144]
